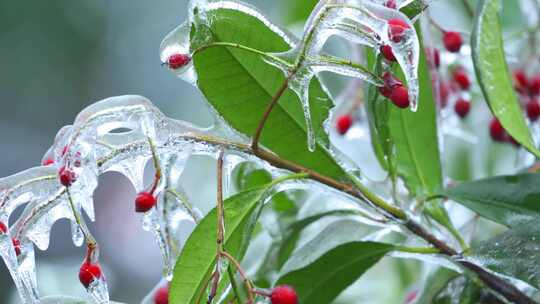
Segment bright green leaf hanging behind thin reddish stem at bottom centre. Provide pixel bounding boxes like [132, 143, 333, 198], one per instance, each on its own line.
[169, 179, 288, 304]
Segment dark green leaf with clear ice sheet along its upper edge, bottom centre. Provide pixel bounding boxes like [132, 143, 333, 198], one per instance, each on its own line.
[277, 221, 393, 304]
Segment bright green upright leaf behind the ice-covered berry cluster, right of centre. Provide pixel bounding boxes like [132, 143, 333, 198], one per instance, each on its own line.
[366, 25, 461, 241]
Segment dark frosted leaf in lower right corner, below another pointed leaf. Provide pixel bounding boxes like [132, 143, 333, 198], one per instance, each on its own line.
[468, 219, 540, 288]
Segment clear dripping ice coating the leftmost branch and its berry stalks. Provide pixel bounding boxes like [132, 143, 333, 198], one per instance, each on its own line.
[0, 96, 388, 303]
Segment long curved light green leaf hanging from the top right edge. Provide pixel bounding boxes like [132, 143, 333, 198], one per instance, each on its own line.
[471, 0, 540, 156]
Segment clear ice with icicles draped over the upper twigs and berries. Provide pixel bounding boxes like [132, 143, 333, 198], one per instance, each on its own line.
[161, 0, 419, 151]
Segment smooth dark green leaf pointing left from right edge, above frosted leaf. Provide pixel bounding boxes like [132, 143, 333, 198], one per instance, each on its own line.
[441, 173, 540, 227]
